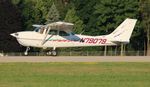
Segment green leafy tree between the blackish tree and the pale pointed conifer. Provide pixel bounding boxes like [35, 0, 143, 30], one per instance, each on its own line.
[18, 0, 52, 30]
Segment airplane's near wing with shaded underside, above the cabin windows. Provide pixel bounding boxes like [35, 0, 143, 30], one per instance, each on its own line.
[47, 21, 74, 32]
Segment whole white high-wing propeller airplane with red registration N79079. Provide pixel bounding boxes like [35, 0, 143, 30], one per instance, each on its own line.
[10, 18, 137, 56]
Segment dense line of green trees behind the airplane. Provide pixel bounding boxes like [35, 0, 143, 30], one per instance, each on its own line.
[0, 0, 150, 55]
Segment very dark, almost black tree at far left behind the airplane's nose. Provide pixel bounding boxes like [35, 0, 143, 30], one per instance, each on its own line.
[0, 0, 22, 52]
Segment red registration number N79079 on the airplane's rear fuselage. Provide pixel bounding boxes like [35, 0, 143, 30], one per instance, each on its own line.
[83, 38, 107, 44]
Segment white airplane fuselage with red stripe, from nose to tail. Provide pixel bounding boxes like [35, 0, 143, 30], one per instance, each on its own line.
[13, 31, 116, 48]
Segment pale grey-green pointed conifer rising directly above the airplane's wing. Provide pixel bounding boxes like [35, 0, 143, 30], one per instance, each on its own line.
[46, 3, 60, 24]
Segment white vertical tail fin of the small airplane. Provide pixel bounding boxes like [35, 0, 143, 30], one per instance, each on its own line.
[108, 18, 137, 43]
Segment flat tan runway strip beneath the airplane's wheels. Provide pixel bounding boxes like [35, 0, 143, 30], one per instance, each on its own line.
[0, 56, 150, 63]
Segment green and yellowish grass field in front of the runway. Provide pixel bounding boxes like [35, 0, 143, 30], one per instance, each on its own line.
[0, 63, 150, 87]
